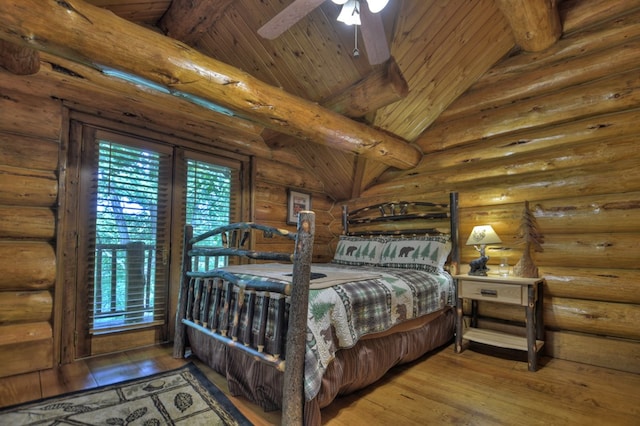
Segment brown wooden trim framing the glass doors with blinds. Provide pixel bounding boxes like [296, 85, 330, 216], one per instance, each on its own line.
[58, 113, 255, 364]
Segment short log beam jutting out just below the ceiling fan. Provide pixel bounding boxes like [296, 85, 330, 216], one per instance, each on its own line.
[321, 58, 409, 118]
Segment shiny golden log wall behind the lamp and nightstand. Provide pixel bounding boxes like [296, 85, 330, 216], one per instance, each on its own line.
[334, 6, 640, 373]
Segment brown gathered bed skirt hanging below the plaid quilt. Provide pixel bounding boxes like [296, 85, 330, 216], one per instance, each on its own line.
[187, 307, 455, 425]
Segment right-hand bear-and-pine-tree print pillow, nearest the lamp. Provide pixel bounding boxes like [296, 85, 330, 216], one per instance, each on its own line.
[380, 235, 451, 272]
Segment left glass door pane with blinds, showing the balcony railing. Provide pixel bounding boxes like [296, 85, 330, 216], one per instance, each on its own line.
[88, 140, 171, 332]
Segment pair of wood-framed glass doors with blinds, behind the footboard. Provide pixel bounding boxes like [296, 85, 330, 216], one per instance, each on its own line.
[61, 121, 248, 362]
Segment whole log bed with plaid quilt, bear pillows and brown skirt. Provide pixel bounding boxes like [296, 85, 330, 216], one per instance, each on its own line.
[174, 193, 459, 425]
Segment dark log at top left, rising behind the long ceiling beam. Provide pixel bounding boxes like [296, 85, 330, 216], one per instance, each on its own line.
[158, 0, 234, 46]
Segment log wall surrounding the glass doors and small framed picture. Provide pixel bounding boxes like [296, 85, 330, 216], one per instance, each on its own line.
[0, 84, 333, 377]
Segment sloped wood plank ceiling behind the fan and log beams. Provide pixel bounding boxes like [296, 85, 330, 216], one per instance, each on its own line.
[1, 0, 555, 201]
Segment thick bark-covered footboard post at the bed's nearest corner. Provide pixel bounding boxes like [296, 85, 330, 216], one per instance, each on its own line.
[282, 211, 316, 426]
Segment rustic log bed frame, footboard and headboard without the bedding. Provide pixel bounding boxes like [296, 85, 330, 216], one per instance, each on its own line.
[173, 193, 459, 425]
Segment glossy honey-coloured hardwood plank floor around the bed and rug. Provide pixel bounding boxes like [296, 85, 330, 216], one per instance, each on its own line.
[0, 346, 640, 426]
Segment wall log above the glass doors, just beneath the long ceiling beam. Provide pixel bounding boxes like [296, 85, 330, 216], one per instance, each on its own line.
[28, 53, 271, 157]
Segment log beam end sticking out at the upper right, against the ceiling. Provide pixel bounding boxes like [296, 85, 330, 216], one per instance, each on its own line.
[496, 0, 562, 52]
